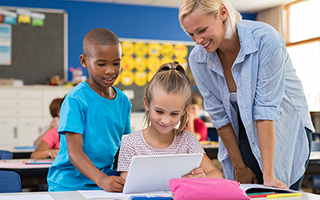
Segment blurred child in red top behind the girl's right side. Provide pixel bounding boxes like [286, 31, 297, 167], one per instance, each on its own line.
[185, 94, 208, 141]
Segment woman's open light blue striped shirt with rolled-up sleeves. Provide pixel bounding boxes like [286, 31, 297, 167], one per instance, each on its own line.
[189, 20, 314, 186]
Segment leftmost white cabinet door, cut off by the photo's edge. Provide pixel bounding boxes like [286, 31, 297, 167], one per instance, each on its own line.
[0, 117, 17, 147]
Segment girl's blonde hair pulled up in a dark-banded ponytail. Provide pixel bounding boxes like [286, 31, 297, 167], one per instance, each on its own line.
[144, 62, 191, 134]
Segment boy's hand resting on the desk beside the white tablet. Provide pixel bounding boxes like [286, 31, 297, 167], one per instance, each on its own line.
[99, 176, 125, 192]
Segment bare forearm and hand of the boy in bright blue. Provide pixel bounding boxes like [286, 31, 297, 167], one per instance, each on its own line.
[65, 132, 125, 192]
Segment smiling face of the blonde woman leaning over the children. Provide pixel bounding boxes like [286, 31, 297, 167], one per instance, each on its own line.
[182, 7, 227, 53]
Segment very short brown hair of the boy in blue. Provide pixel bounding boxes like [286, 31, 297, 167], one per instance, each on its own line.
[83, 28, 120, 57]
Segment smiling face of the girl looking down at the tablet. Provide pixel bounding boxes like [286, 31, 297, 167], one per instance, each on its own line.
[144, 88, 186, 134]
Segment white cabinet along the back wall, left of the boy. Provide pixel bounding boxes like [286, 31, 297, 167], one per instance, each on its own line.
[0, 86, 72, 148]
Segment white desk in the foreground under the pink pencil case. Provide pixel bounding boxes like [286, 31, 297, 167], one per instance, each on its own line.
[0, 191, 320, 200]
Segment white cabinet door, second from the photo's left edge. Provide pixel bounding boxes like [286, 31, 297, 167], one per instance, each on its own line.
[17, 118, 42, 146]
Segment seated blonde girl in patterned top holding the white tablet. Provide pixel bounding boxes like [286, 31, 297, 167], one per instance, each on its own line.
[117, 62, 222, 179]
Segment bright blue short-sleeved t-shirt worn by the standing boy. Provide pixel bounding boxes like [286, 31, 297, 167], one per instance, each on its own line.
[47, 82, 131, 191]
